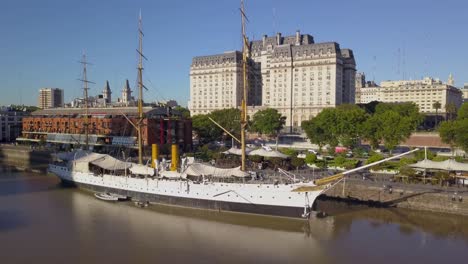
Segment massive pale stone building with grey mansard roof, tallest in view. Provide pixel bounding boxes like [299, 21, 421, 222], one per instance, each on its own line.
[189, 31, 356, 127]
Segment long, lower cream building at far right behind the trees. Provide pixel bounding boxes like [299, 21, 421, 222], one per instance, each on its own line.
[356, 77, 462, 114]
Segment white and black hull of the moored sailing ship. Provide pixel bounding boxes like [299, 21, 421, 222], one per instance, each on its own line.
[49, 164, 322, 217]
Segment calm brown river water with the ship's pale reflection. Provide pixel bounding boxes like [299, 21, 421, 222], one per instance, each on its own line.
[0, 168, 468, 263]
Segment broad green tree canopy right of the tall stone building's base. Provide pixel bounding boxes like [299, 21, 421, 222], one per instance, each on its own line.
[302, 103, 423, 150]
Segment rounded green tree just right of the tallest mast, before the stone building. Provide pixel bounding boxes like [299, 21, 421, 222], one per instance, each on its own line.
[250, 108, 286, 136]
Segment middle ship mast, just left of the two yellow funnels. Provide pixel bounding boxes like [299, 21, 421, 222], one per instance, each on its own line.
[137, 10, 146, 164]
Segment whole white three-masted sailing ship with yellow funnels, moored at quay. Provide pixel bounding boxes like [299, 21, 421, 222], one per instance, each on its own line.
[49, 7, 418, 220]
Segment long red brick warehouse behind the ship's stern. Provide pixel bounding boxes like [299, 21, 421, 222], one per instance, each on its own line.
[17, 107, 192, 151]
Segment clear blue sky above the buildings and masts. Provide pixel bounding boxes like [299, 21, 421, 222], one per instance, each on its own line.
[0, 0, 468, 105]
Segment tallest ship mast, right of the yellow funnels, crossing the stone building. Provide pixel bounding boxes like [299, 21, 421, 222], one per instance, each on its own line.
[241, 0, 249, 171]
